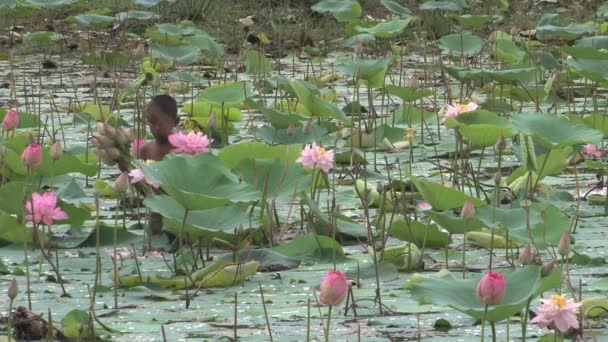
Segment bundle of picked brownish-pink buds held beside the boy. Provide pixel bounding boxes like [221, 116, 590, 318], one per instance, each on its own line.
[91, 122, 133, 168]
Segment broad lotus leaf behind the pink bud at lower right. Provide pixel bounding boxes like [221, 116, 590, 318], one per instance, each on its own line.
[411, 266, 561, 322]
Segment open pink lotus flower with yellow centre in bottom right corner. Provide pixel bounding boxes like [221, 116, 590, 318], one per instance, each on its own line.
[530, 295, 583, 333]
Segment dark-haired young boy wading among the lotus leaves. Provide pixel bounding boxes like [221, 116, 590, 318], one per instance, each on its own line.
[139, 94, 179, 234]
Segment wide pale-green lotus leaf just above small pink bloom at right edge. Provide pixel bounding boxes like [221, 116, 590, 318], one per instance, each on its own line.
[511, 112, 603, 148]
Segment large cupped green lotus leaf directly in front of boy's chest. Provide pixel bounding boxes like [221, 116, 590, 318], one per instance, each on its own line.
[140, 153, 260, 210]
